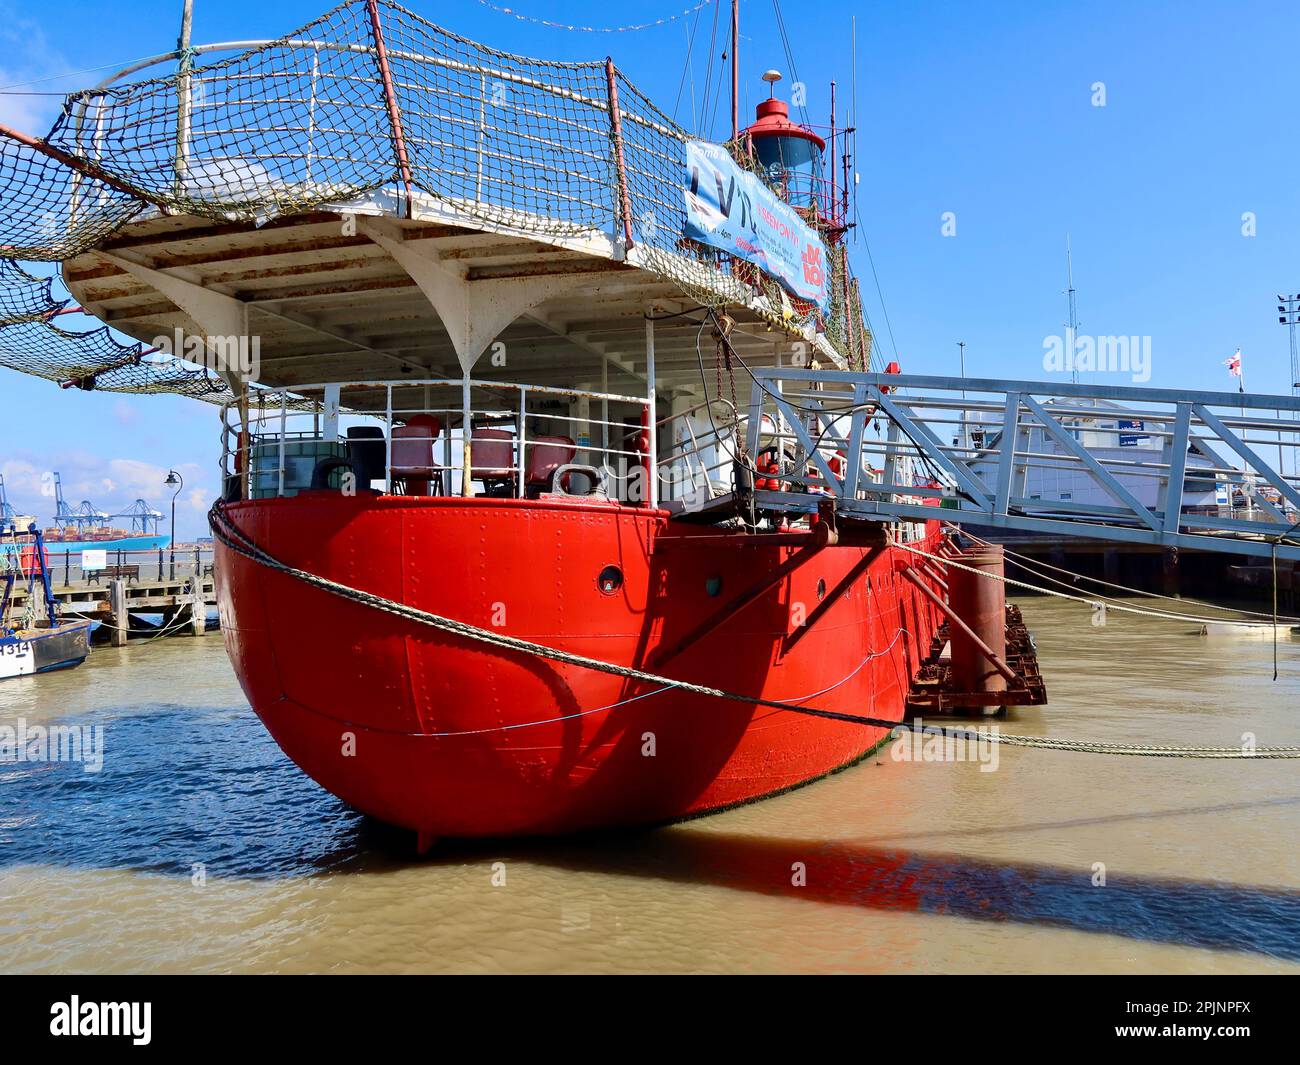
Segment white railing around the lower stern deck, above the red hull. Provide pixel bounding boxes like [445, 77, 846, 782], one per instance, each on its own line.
[221, 378, 649, 503]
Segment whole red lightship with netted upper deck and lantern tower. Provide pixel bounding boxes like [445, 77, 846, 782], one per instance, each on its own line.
[25, 0, 1034, 840]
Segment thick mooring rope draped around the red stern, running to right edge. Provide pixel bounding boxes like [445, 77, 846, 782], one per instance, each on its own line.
[208, 502, 1300, 759]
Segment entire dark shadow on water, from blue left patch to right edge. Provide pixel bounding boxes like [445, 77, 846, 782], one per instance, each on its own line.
[0, 705, 1300, 961]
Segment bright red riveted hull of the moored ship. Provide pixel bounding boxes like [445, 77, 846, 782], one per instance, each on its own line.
[217, 493, 939, 836]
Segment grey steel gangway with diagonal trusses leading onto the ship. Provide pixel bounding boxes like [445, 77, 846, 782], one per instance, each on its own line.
[670, 368, 1300, 560]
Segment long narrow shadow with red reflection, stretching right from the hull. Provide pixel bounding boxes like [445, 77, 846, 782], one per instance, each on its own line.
[499, 827, 1300, 961]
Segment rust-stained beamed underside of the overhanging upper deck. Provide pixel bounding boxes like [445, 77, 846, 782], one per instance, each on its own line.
[64, 202, 816, 389]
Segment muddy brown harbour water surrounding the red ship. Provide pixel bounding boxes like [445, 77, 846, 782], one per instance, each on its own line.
[0, 598, 1300, 973]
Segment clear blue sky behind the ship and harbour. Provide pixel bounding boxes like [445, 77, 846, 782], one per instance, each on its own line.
[0, 0, 1300, 536]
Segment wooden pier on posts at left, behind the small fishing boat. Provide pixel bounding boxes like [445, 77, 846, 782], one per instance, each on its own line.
[10, 573, 217, 646]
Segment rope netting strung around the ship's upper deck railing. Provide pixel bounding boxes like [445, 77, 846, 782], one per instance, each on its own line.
[0, 0, 865, 388]
